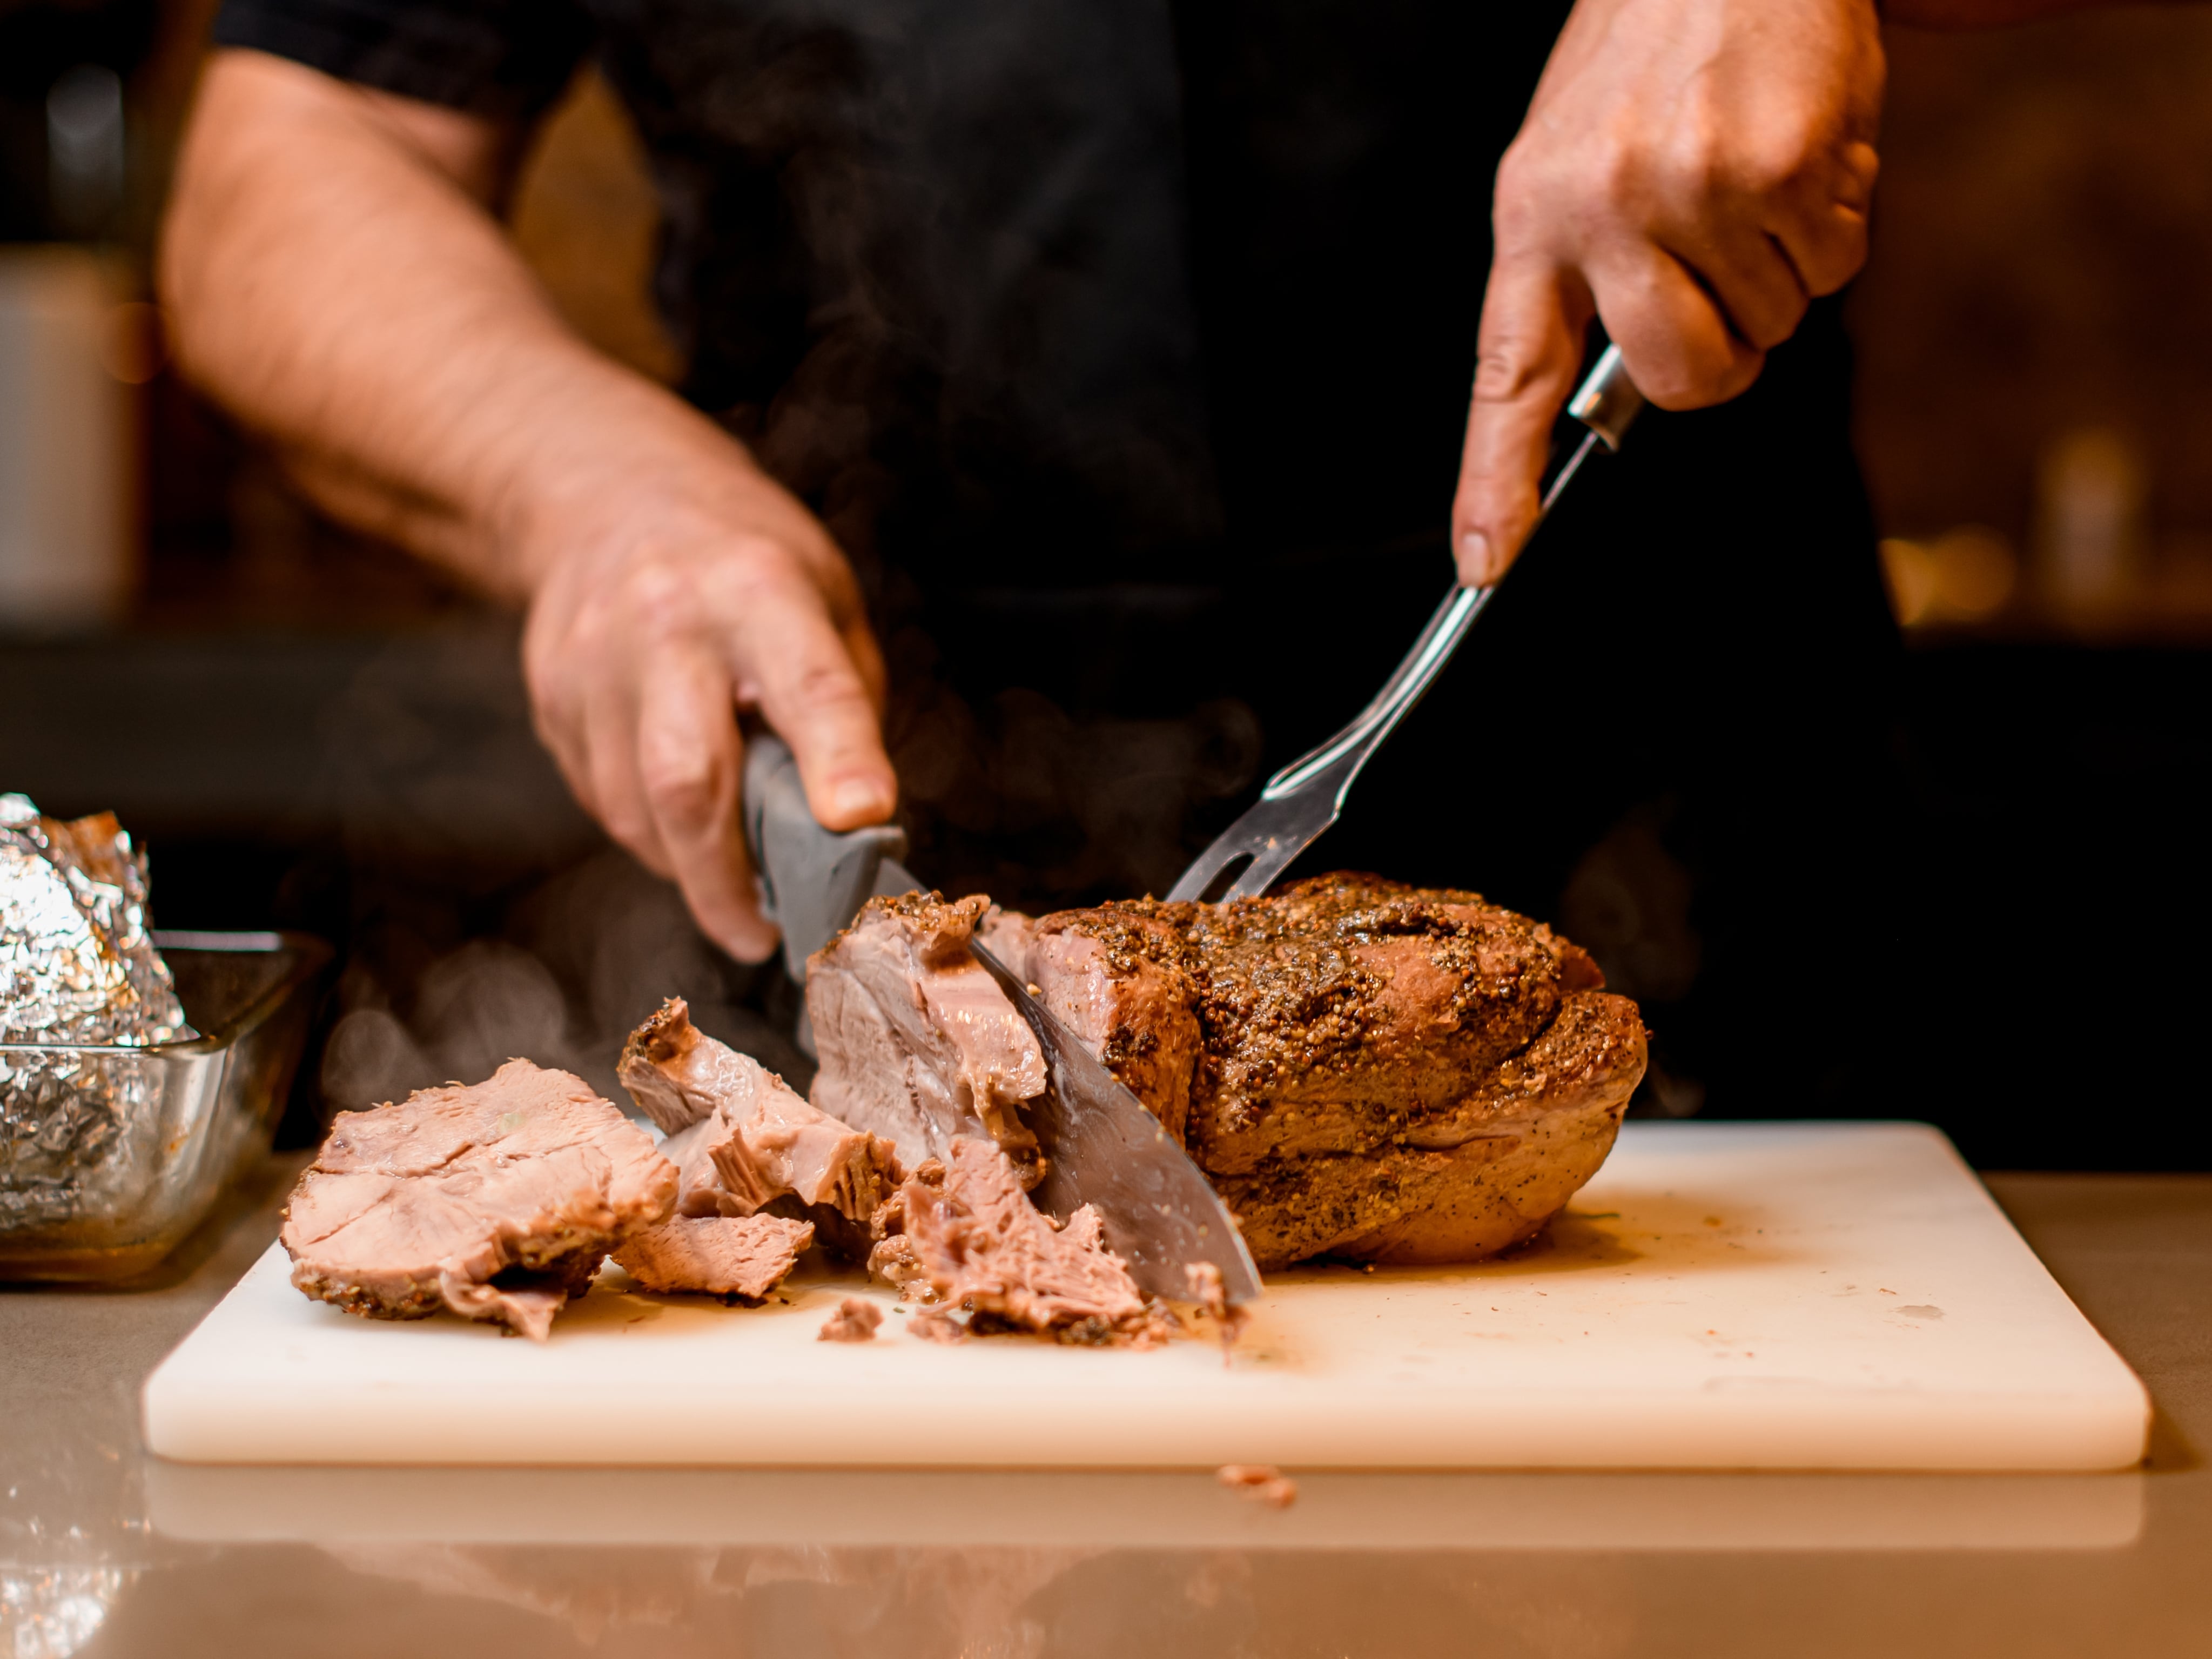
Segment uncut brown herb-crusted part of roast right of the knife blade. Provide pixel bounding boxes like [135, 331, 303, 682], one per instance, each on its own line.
[1028, 876, 1646, 1270]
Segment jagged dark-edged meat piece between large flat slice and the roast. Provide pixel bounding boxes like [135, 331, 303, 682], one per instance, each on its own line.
[617, 998, 905, 1261]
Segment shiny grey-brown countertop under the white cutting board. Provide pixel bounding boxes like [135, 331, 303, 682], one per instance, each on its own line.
[0, 1159, 2212, 1659]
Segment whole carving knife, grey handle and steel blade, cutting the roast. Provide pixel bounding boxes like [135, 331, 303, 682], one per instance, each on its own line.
[743, 732, 1259, 1307]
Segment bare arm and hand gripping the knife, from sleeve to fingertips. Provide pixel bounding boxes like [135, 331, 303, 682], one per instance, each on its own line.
[162, 51, 896, 960]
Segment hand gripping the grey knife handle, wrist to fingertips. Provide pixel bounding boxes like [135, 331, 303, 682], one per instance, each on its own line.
[522, 480, 898, 960]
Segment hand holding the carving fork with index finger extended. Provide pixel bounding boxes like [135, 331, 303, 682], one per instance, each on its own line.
[1453, 0, 1882, 586]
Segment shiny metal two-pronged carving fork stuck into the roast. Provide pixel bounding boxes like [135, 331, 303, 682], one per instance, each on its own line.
[1170, 345, 1644, 898]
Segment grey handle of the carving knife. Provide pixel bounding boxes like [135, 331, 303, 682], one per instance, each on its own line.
[743, 732, 907, 984]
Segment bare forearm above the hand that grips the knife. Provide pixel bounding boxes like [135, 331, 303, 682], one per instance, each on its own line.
[162, 53, 785, 597]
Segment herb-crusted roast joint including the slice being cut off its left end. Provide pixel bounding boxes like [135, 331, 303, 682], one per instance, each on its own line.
[808, 874, 1644, 1270]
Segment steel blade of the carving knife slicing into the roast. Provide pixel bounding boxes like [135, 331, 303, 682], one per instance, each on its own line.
[973, 944, 1259, 1307]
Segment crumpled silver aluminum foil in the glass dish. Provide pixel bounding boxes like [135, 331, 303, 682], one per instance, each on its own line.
[0, 794, 197, 1228]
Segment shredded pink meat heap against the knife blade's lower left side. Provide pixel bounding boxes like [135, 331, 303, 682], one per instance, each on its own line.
[880, 1137, 1155, 1340]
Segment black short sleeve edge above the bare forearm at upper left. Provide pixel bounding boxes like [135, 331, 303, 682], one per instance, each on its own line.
[214, 0, 593, 119]
